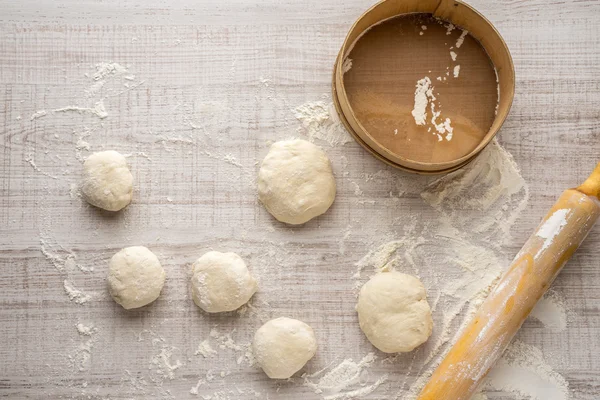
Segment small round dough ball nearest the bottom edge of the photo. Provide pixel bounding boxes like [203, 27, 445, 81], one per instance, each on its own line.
[252, 318, 317, 379]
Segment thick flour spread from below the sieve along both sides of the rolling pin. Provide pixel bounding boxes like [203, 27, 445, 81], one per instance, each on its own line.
[353, 142, 571, 400]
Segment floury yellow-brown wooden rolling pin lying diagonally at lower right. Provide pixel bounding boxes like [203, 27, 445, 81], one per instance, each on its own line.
[417, 164, 600, 400]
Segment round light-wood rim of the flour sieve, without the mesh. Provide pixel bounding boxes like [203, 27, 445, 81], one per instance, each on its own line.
[333, 0, 515, 173]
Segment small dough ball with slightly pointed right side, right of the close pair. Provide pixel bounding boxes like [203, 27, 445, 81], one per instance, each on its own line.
[192, 251, 258, 313]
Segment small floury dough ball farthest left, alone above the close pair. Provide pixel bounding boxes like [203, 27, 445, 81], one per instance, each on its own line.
[81, 150, 133, 211]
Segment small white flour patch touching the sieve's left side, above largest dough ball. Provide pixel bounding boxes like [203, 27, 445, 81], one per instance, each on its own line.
[294, 101, 352, 147]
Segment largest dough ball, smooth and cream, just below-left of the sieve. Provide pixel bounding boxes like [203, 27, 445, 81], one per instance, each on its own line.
[258, 139, 335, 225]
